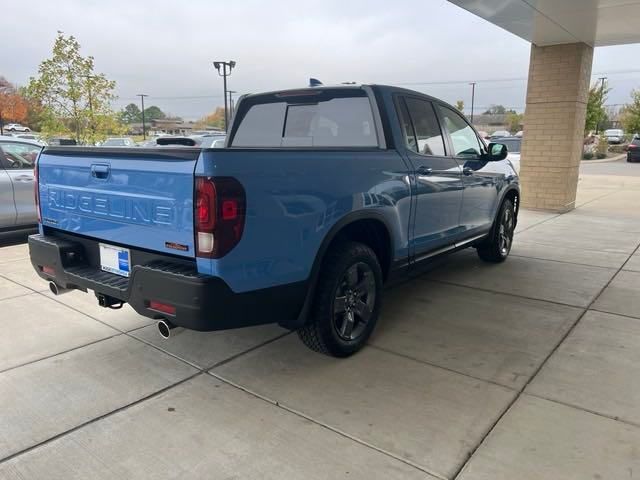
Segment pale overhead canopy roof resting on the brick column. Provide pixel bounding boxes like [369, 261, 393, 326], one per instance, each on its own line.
[449, 0, 640, 47]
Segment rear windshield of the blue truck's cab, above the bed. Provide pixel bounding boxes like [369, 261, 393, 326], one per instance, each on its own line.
[230, 91, 378, 147]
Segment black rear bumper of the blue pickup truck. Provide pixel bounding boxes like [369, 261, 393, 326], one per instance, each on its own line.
[29, 234, 307, 331]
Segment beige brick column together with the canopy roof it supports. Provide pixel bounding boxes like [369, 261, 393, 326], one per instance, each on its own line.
[449, 0, 640, 212]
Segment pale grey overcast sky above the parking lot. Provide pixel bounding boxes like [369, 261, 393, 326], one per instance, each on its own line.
[0, 0, 640, 119]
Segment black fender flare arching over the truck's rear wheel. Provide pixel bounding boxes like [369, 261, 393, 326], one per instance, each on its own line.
[280, 209, 395, 330]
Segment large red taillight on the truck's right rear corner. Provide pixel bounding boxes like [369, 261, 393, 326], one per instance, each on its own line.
[195, 177, 246, 258]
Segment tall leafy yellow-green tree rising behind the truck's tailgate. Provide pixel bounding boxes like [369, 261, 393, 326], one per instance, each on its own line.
[26, 32, 122, 143]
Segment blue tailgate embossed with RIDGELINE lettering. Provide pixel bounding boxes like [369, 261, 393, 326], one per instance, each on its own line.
[38, 147, 200, 257]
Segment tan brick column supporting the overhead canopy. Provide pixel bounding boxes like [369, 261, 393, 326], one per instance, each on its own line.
[520, 43, 593, 212]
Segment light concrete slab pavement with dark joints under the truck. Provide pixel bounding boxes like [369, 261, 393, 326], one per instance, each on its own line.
[0, 164, 640, 480]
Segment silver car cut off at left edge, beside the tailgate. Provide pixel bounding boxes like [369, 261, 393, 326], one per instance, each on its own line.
[0, 137, 42, 231]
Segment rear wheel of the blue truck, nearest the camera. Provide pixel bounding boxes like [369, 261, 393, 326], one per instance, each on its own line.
[298, 242, 382, 357]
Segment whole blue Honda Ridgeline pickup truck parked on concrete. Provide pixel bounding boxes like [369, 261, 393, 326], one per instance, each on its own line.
[29, 85, 520, 356]
